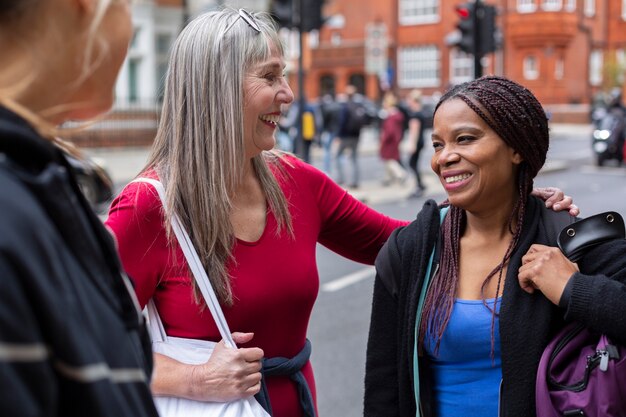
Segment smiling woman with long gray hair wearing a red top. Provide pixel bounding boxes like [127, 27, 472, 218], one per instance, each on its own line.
[107, 9, 406, 417]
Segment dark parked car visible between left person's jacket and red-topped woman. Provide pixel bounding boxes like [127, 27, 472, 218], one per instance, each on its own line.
[66, 153, 113, 214]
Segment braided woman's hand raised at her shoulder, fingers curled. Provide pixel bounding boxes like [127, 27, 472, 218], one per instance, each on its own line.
[517, 244, 578, 305]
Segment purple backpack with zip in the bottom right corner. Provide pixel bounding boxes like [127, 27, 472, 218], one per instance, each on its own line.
[535, 323, 626, 417]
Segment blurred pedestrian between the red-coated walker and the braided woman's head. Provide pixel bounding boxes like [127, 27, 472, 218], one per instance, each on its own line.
[407, 89, 426, 198]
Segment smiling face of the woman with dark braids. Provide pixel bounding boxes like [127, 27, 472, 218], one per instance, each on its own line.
[431, 99, 522, 212]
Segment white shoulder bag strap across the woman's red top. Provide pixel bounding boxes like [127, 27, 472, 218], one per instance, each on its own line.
[132, 177, 237, 348]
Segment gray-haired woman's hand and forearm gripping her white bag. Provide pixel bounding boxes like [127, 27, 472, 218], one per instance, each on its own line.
[152, 333, 263, 402]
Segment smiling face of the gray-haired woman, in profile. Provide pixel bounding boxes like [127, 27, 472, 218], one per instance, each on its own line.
[243, 49, 293, 158]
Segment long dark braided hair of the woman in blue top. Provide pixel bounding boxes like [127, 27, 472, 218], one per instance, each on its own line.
[418, 76, 549, 359]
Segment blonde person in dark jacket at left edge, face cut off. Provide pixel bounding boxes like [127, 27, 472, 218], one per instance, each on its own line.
[0, 0, 157, 417]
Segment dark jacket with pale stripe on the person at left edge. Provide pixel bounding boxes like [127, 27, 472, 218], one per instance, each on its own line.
[0, 107, 157, 417]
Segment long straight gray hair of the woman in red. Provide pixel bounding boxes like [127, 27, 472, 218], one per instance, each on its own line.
[146, 9, 293, 305]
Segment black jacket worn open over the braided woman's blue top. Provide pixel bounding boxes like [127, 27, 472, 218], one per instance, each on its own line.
[364, 197, 626, 417]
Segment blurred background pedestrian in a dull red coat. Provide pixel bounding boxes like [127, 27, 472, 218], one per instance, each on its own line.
[380, 92, 408, 185]
